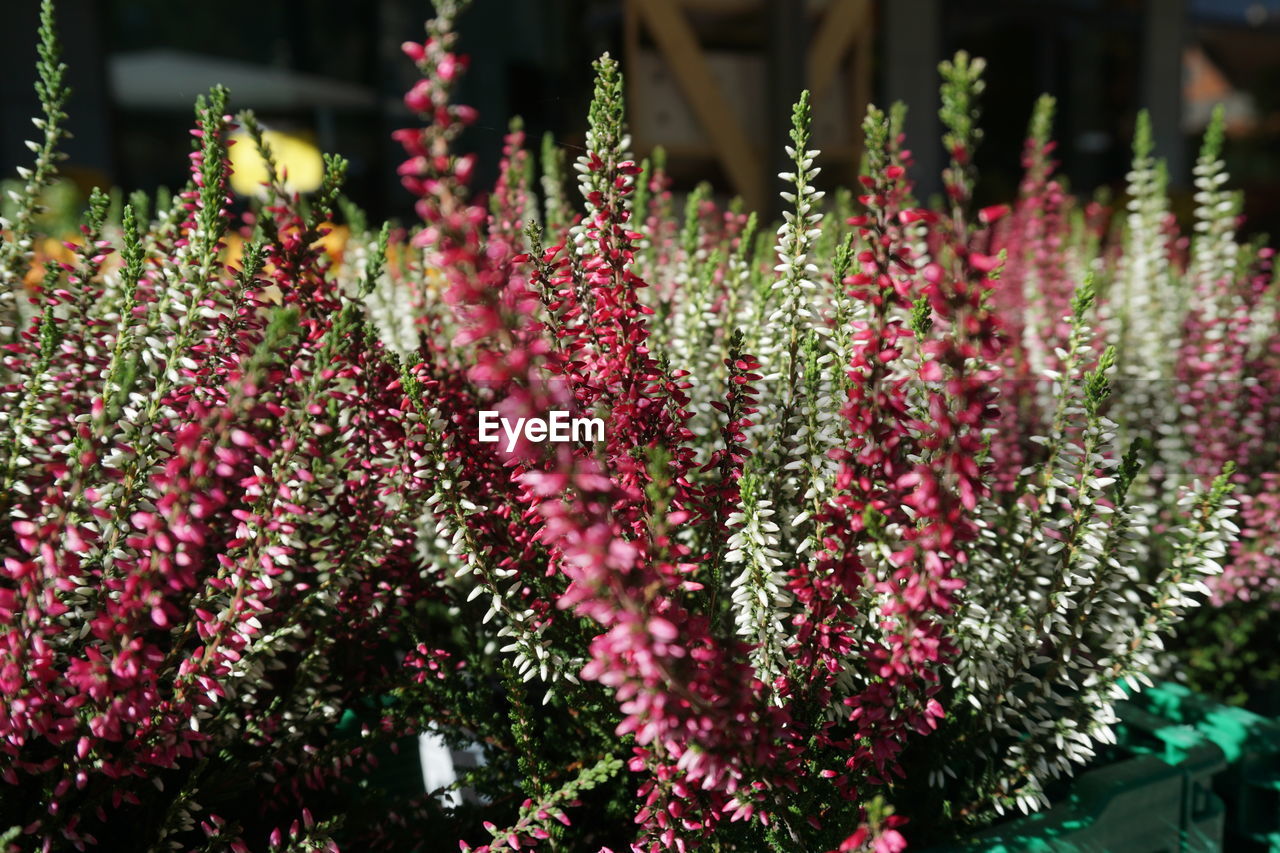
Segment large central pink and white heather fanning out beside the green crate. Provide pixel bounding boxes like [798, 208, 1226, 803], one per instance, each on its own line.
[389, 9, 1234, 849]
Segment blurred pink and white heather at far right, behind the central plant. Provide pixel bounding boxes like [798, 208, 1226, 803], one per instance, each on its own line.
[997, 100, 1280, 701]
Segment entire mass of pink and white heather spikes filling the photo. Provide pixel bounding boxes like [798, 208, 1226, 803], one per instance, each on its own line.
[0, 0, 1264, 852]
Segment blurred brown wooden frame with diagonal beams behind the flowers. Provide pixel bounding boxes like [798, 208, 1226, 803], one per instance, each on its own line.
[623, 0, 874, 210]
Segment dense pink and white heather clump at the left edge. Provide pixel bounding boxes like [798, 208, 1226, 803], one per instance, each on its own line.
[0, 3, 483, 849]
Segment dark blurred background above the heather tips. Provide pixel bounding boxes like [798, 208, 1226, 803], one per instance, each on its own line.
[0, 0, 1280, 233]
